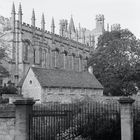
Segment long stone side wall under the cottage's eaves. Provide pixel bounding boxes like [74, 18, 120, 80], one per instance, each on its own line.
[41, 88, 103, 103]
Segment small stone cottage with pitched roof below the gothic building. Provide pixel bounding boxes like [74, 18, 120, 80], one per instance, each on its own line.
[18, 67, 103, 103]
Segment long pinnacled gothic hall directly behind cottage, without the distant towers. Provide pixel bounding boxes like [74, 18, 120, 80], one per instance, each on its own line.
[1, 4, 91, 83]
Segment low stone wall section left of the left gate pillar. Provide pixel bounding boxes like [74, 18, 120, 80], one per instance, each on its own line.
[0, 104, 15, 140]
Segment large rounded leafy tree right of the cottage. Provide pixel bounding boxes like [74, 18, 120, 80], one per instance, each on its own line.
[88, 29, 140, 95]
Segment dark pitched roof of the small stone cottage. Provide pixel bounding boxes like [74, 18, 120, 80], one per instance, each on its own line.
[31, 67, 103, 89]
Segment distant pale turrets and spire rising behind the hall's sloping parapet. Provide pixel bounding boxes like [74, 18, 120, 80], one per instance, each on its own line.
[60, 14, 105, 47]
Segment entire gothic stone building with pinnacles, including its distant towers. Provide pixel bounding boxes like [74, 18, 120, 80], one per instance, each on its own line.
[0, 4, 118, 85]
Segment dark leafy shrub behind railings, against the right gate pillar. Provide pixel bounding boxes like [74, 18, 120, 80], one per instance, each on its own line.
[73, 102, 120, 140]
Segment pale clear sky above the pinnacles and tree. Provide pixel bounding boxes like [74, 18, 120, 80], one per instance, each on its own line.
[0, 0, 140, 38]
